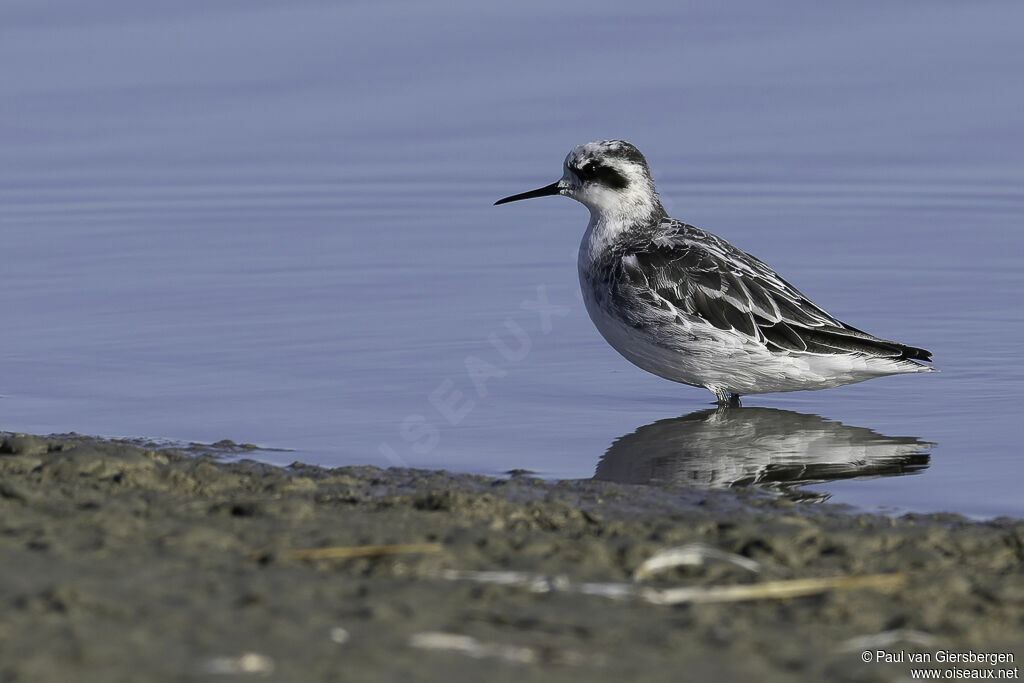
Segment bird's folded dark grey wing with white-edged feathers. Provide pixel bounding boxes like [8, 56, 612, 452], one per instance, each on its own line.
[614, 219, 931, 360]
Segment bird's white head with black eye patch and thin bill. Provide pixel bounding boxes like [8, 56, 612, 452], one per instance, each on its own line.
[495, 140, 664, 225]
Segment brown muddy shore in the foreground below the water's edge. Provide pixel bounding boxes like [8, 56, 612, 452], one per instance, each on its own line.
[0, 434, 1024, 683]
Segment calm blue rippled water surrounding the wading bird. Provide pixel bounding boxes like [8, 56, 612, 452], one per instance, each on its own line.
[0, 0, 1024, 516]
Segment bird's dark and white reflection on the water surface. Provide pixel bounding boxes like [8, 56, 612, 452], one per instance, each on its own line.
[594, 408, 935, 501]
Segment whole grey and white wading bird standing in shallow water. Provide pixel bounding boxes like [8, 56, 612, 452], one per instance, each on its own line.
[497, 140, 934, 402]
